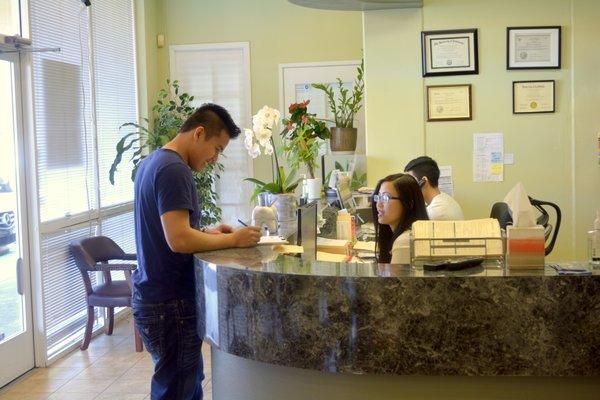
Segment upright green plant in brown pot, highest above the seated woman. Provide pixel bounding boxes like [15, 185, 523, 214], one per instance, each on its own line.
[312, 62, 365, 152]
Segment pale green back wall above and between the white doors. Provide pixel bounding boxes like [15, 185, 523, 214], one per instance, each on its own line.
[137, 0, 362, 179]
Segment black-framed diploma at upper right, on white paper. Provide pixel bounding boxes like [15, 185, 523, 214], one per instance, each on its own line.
[506, 26, 560, 69]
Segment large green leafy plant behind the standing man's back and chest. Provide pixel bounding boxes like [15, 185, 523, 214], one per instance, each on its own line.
[109, 79, 223, 226]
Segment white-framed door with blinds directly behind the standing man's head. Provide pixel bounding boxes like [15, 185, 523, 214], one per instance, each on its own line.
[170, 43, 252, 223]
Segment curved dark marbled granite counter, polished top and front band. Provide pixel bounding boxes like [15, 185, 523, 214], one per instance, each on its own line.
[195, 247, 600, 376]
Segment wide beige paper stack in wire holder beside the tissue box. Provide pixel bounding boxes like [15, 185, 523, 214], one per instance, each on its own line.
[412, 218, 504, 258]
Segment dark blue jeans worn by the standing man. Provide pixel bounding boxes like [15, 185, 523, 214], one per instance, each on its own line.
[132, 296, 204, 400]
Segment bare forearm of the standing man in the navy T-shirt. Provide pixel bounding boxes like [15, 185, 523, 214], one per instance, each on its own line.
[160, 210, 260, 254]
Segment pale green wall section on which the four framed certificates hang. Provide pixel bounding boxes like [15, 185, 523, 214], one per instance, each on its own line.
[363, 0, 600, 260]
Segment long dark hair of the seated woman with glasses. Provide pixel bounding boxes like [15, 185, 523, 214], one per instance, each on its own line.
[371, 174, 429, 263]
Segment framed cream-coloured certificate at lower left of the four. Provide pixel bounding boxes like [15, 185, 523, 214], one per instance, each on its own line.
[427, 85, 471, 121]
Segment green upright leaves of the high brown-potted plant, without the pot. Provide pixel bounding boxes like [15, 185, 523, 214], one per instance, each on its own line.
[312, 61, 365, 128]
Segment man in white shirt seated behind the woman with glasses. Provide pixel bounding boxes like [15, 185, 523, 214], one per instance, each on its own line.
[404, 156, 465, 221]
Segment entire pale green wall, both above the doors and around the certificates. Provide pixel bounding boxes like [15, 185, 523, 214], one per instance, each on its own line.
[136, 0, 600, 260]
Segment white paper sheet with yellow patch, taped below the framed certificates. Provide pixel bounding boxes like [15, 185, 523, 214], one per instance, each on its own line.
[473, 133, 504, 182]
